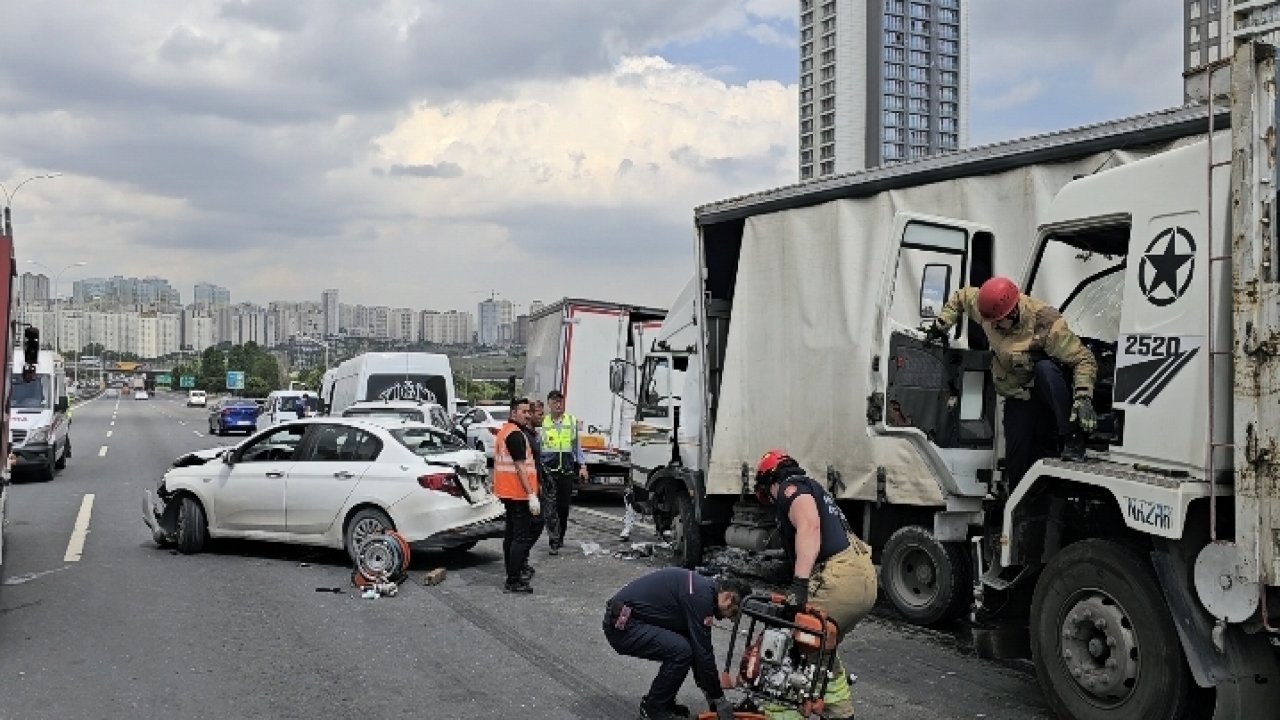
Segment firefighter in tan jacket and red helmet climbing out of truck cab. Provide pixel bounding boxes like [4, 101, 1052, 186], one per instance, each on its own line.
[925, 277, 1098, 483]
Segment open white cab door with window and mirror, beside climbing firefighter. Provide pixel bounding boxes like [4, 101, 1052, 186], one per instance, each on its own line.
[867, 213, 996, 504]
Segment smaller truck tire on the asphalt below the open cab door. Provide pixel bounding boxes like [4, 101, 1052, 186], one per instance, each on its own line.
[881, 525, 973, 625]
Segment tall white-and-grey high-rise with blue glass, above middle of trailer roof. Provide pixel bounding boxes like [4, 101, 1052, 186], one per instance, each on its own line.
[799, 0, 969, 175]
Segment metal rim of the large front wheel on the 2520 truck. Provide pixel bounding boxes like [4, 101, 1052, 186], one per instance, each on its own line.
[1059, 589, 1142, 708]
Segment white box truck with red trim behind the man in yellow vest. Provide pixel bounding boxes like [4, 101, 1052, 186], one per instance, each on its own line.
[525, 299, 666, 492]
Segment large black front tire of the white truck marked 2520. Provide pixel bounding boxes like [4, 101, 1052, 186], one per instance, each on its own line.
[1030, 539, 1194, 720]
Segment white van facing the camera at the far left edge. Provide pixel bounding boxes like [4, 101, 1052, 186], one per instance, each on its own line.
[9, 350, 72, 480]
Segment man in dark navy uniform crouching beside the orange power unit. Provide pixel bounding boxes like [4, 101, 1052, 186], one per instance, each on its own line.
[604, 568, 751, 720]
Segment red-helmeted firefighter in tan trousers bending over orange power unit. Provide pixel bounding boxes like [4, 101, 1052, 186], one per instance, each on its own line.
[755, 450, 877, 720]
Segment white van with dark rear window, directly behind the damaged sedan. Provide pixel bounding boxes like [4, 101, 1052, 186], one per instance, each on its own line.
[321, 352, 457, 416]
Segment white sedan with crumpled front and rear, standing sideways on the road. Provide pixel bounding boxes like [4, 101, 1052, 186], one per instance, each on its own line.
[143, 418, 503, 557]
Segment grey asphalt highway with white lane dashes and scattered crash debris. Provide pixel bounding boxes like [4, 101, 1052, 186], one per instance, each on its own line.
[0, 391, 1048, 720]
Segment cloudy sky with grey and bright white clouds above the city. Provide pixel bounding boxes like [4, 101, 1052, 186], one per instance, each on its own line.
[0, 0, 1181, 310]
